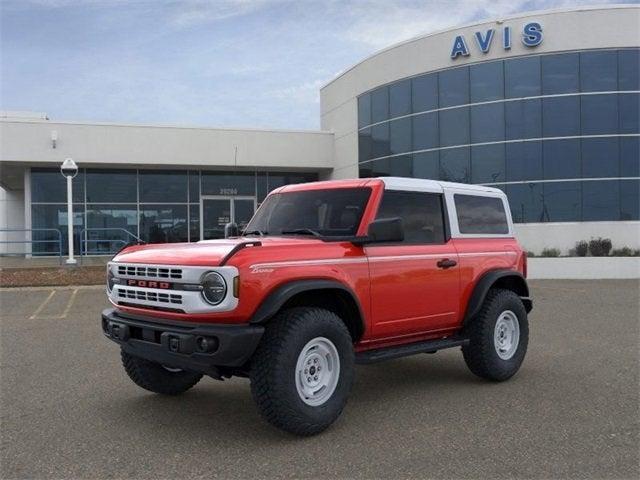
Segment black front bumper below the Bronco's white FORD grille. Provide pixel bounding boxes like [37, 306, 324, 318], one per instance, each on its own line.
[102, 308, 264, 376]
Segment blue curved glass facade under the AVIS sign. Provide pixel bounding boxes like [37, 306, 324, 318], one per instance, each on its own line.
[358, 49, 640, 222]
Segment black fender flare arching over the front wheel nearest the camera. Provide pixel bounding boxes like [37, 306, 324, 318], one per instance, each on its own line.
[249, 279, 365, 338]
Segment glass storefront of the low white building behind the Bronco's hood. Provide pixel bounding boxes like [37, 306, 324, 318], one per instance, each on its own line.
[31, 168, 318, 255]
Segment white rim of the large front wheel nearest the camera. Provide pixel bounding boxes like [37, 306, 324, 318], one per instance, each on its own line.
[295, 337, 340, 407]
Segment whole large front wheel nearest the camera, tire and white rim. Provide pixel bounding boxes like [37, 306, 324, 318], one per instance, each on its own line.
[251, 307, 354, 435]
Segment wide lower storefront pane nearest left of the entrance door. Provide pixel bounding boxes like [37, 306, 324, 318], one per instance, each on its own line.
[140, 205, 189, 243]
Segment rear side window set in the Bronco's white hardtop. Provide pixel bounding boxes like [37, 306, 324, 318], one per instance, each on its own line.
[453, 193, 509, 234]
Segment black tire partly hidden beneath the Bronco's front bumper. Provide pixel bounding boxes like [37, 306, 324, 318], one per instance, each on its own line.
[120, 350, 202, 395]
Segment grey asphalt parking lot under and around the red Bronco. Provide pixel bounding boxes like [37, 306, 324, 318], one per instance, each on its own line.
[0, 281, 640, 479]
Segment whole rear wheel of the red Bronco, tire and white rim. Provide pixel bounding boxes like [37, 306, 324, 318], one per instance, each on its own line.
[462, 289, 529, 381]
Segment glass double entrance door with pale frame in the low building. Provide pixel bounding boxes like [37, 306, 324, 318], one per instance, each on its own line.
[200, 195, 256, 240]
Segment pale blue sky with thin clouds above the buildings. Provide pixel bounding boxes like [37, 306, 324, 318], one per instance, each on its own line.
[0, 0, 638, 129]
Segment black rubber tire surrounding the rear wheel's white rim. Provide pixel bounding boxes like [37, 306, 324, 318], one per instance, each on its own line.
[462, 288, 529, 382]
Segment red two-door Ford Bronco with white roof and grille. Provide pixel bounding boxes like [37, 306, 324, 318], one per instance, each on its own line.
[102, 178, 532, 435]
